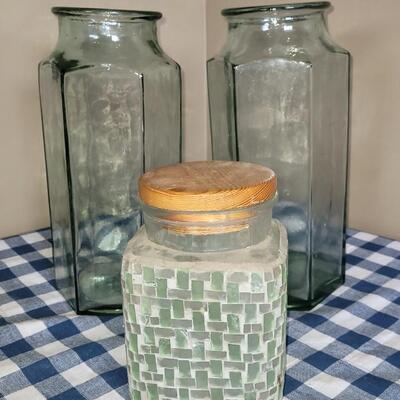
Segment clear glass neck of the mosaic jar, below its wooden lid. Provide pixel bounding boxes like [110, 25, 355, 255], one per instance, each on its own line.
[142, 200, 274, 252]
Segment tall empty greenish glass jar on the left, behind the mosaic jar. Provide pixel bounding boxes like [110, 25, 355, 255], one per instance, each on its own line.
[39, 8, 181, 312]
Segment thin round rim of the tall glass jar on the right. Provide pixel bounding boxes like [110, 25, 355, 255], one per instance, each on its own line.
[221, 1, 331, 17]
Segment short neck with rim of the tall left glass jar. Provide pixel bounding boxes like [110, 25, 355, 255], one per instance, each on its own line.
[54, 9, 159, 49]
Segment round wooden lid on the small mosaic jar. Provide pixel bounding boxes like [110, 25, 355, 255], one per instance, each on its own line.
[139, 161, 276, 211]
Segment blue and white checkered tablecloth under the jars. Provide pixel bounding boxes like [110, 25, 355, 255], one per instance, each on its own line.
[0, 230, 400, 400]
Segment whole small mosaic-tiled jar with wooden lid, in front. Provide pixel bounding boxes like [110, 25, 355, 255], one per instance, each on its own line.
[122, 161, 287, 400]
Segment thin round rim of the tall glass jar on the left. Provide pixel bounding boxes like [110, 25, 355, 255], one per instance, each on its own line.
[51, 7, 162, 21]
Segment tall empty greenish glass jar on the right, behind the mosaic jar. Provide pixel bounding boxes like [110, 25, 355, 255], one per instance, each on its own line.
[208, 2, 350, 308]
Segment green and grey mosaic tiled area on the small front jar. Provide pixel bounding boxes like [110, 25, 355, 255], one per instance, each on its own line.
[122, 263, 287, 400]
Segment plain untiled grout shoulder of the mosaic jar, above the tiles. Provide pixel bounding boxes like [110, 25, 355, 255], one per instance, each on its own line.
[123, 220, 287, 272]
